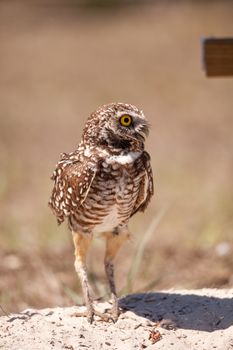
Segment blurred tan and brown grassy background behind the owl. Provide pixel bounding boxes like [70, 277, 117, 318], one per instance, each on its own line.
[0, 0, 233, 314]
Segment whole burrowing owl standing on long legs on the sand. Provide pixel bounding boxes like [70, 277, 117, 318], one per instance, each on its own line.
[49, 103, 153, 322]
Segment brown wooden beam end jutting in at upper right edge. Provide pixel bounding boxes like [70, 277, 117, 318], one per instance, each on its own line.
[203, 38, 233, 77]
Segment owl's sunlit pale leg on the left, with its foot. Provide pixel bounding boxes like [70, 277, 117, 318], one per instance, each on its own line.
[72, 232, 94, 322]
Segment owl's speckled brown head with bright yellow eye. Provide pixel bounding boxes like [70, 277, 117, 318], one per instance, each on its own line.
[83, 103, 149, 151]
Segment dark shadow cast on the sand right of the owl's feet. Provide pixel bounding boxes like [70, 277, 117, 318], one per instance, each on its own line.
[120, 292, 233, 332]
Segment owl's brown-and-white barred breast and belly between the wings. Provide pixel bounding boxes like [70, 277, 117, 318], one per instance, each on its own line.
[68, 152, 145, 233]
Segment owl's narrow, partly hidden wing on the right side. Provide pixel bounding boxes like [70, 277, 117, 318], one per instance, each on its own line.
[131, 151, 154, 216]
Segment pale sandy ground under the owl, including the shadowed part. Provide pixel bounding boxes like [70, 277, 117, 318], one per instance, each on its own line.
[0, 289, 233, 350]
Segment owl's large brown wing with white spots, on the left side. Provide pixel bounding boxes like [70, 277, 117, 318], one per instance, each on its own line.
[49, 152, 98, 224]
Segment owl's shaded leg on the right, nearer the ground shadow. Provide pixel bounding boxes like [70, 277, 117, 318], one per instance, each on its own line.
[104, 232, 130, 321]
